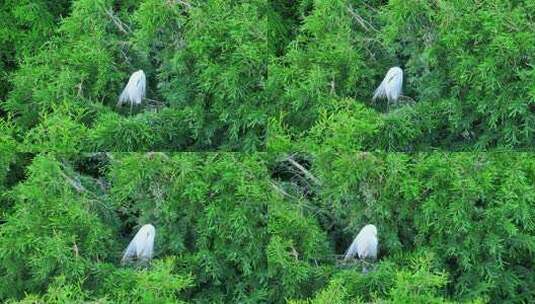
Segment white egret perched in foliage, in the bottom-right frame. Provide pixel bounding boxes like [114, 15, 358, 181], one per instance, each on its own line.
[344, 224, 379, 272]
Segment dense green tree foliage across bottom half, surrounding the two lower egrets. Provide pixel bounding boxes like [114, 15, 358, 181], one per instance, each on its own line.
[0, 152, 535, 303]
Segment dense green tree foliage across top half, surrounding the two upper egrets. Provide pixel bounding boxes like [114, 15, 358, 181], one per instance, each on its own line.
[0, 0, 535, 151]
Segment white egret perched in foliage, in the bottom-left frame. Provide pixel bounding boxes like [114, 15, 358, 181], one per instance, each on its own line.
[121, 224, 156, 264]
